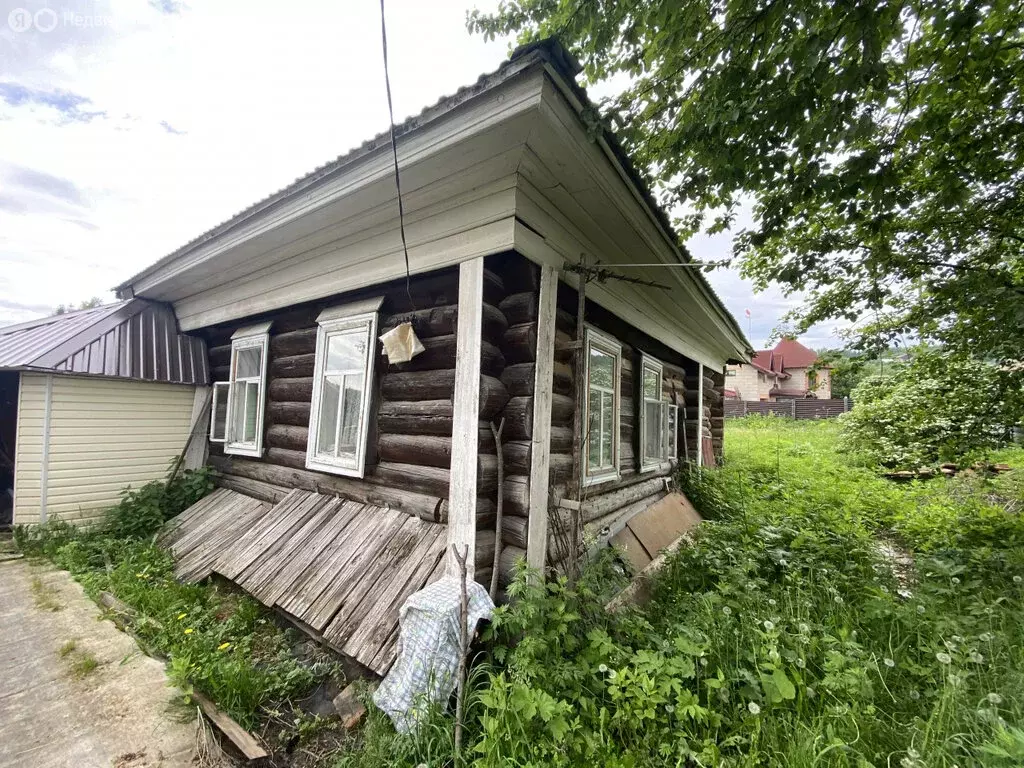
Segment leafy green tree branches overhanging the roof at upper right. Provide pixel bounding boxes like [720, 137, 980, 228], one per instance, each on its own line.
[469, 0, 1024, 359]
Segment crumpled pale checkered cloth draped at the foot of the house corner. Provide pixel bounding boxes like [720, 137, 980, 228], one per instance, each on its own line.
[374, 577, 495, 733]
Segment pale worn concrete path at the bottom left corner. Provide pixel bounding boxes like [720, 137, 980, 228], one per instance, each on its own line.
[0, 560, 198, 768]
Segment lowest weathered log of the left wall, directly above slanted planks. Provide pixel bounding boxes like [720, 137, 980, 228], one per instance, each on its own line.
[210, 449, 441, 517]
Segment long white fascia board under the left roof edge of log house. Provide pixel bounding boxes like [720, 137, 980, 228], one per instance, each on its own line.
[130, 68, 545, 303]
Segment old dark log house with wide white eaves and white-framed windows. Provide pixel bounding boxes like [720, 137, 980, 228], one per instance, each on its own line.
[118, 41, 751, 667]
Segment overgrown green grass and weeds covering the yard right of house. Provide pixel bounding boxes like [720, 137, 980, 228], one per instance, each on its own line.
[339, 418, 1024, 768]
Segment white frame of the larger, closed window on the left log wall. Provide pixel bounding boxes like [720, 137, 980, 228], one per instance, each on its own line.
[306, 296, 384, 477]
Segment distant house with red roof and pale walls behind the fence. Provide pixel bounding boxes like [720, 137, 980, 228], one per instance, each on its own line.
[725, 339, 831, 400]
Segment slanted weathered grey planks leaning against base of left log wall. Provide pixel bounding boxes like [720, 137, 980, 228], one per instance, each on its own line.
[161, 488, 447, 675]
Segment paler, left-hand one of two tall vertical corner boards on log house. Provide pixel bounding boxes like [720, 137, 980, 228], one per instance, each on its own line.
[447, 256, 483, 575]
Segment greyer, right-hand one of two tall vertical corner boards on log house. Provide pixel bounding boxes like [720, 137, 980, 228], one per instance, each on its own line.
[528, 265, 561, 573]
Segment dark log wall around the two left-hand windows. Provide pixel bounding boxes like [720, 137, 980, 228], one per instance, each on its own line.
[203, 269, 508, 544]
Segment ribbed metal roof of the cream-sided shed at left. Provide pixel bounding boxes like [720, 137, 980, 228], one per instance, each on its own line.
[0, 299, 210, 384]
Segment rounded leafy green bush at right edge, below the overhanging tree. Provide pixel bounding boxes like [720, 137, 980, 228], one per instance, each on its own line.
[842, 350, 1021, 469]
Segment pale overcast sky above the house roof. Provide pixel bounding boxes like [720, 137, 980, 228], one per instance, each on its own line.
[0, 0, 838, 347]
